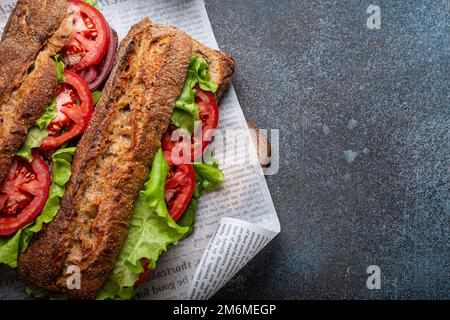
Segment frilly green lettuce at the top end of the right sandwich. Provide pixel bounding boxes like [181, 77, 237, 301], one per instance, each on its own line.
[172, 56, 217, 132]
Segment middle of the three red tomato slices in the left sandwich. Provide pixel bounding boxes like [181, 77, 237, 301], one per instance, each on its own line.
[40, 70, 94, 150]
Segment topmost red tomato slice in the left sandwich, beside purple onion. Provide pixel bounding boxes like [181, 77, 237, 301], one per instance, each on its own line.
[61, 0, 110, 72]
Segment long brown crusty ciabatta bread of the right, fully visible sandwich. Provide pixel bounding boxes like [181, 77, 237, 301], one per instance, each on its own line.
[18, 19, 234, 299]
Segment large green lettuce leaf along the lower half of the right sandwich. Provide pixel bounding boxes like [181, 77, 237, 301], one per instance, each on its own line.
[97, 149, 189, 299]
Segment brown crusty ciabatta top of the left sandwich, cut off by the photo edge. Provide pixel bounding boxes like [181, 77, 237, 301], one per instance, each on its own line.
[0, 0, 69, 181]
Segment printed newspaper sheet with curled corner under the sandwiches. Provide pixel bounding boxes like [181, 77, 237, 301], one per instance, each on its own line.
[0, 0, 280, 299]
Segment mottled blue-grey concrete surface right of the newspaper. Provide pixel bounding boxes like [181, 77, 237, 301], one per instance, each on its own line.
[206, 0, 450, 299]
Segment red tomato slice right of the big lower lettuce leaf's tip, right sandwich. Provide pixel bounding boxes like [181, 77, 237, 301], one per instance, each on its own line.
[164, 153, 196, 221]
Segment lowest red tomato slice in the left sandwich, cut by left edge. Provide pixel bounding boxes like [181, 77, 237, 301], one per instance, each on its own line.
[0, 152, 50, 236]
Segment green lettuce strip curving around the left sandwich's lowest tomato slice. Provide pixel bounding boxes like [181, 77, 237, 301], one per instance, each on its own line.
[0, 148, 75, 268]
